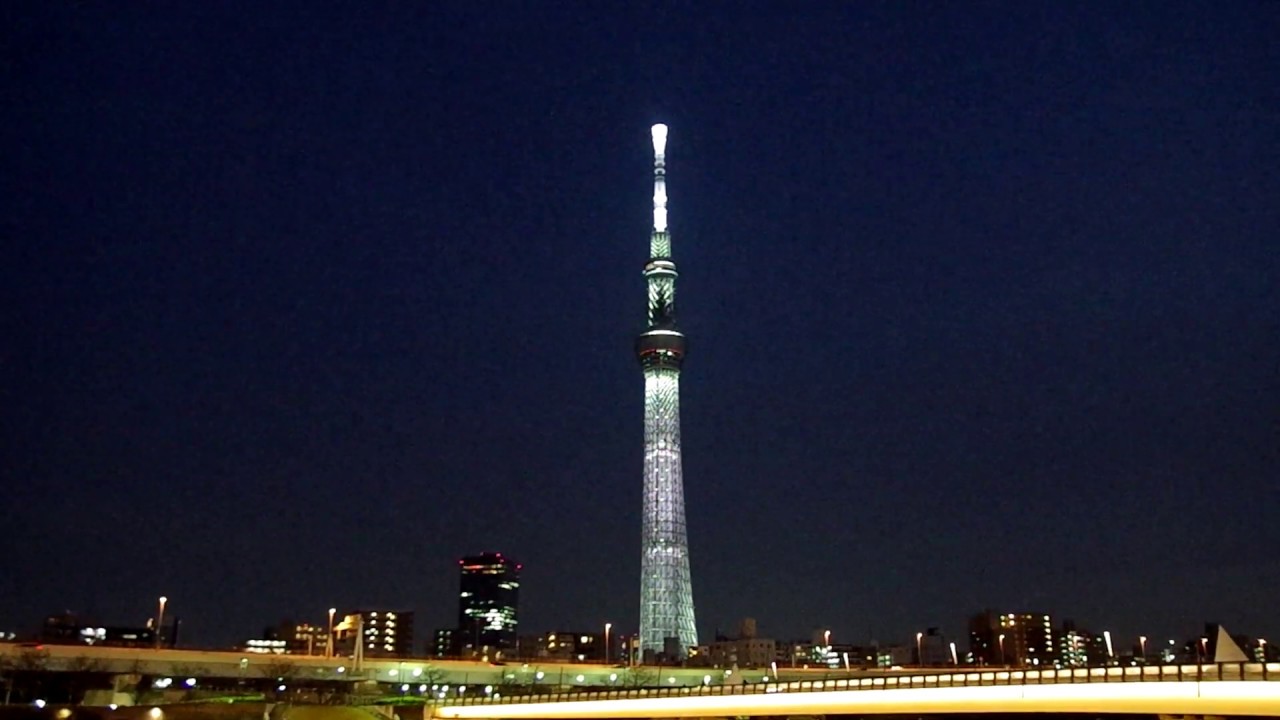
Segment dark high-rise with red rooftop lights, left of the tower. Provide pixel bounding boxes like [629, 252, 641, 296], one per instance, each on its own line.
[454, 552, 521, 655]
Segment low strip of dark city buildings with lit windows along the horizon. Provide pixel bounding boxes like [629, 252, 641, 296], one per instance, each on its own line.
[10, 573, 1271, 665]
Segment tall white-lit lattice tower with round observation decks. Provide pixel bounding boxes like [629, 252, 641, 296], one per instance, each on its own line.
[636, 124, 698, 656]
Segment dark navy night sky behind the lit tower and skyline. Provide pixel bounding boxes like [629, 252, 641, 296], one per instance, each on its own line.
[0, 0, 1280, 647]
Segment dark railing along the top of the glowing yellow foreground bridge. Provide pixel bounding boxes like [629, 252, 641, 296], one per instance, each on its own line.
[439, 662, 1280, 706]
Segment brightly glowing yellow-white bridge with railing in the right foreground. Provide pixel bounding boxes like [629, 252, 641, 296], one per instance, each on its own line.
[430, 662, 1280, 720]
